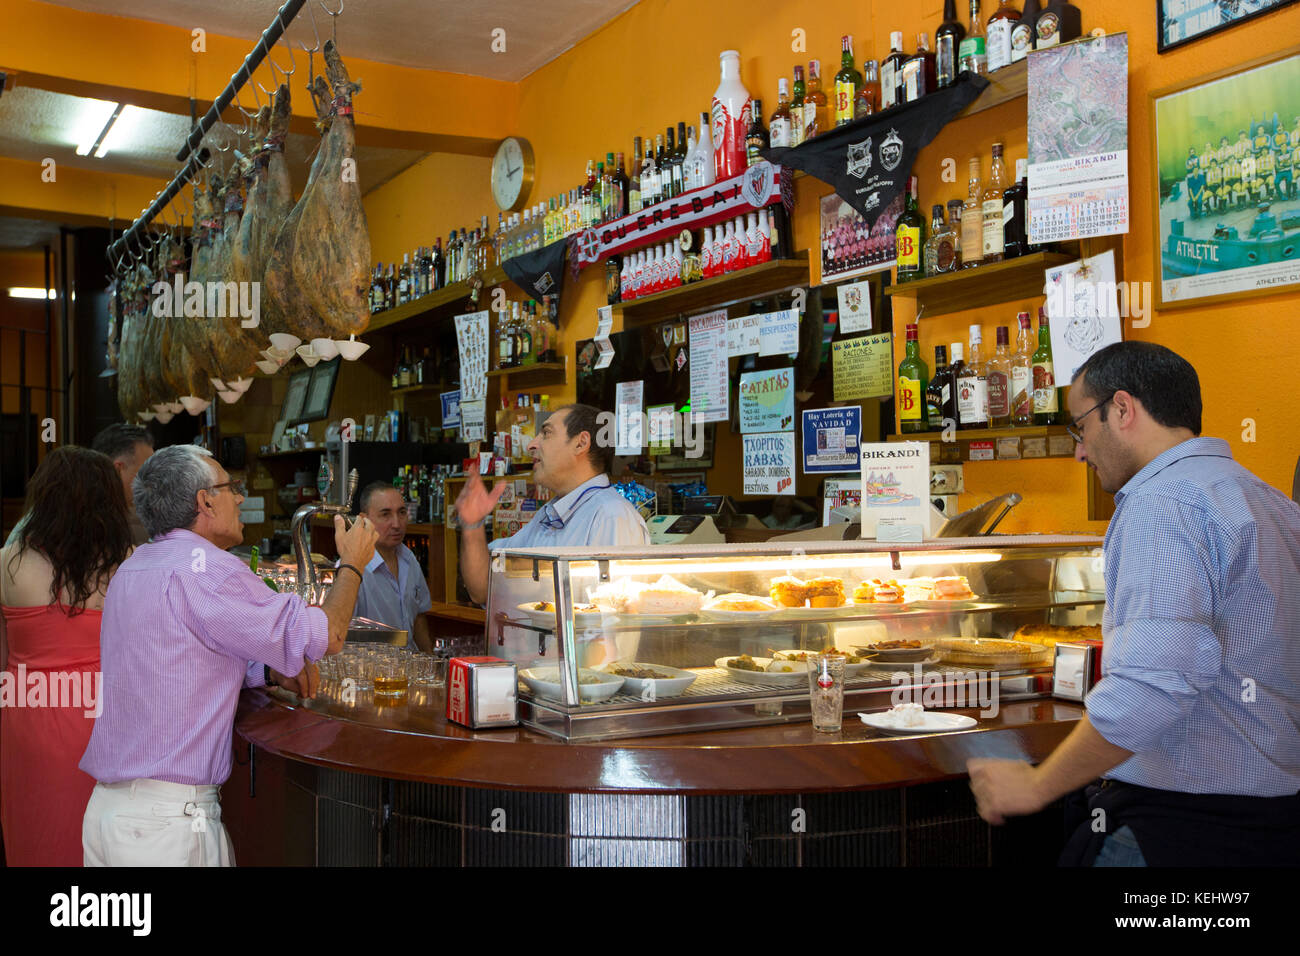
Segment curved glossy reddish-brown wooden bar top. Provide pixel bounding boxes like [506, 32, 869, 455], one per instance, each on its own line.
[235, 689, 1084, 795]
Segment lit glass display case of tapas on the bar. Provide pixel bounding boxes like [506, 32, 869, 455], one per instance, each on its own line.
[488, 535, 1105, 740]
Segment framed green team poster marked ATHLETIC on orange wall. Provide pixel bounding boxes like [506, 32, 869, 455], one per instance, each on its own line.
[1151, 47, 1300, 308]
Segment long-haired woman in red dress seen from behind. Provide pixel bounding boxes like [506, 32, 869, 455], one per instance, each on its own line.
[0, 446, 131, 866]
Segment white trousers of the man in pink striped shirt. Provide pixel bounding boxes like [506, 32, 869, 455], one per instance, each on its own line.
[82, 778, 235, 866]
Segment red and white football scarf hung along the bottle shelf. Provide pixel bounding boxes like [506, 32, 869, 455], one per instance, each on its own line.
[569, 163, 794, 268]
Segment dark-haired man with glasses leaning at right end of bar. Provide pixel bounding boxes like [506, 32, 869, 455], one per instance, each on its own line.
[967, 342, 1300, 866]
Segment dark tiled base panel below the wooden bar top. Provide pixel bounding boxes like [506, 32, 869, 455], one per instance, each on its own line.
[239, 750, 1063, 868]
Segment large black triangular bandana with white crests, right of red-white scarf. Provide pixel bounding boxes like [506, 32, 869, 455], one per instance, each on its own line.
[763, 73, 988, 239]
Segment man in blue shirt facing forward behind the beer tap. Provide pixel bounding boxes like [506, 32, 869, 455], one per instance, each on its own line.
[355, 481, 433, 652]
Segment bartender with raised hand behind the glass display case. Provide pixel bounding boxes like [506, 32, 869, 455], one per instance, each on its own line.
[456, 405, 650, 604]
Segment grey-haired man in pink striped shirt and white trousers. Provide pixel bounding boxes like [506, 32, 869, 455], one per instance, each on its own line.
[81, 445, 376, 866]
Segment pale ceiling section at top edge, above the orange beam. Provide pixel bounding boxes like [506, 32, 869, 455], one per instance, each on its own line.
[46, 0, 637, 82]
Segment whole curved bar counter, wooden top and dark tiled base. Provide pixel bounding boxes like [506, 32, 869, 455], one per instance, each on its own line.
[222, 691, 1083, 866]
